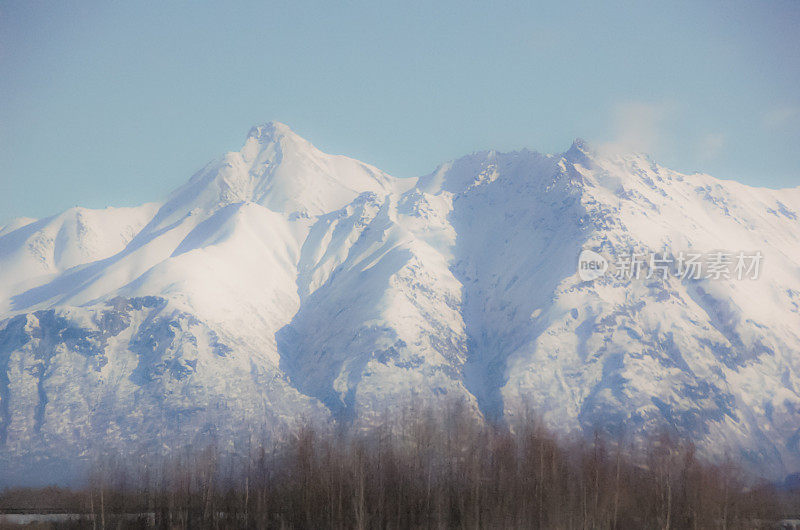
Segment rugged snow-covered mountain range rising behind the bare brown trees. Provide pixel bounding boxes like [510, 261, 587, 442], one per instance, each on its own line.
[0, 123, 800, 482]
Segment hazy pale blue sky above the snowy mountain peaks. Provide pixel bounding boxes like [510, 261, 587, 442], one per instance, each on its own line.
[0, 0, 800, 223]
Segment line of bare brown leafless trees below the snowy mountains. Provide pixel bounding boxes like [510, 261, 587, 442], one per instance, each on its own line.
[0, 407, 800, 529]
